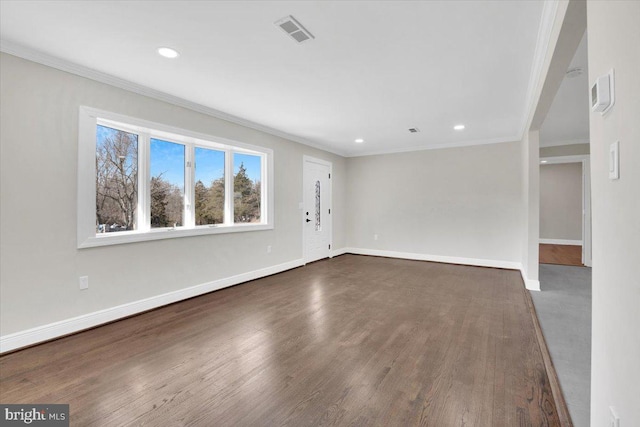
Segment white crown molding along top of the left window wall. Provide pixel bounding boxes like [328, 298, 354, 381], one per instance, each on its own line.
[0, 39, 346, 157]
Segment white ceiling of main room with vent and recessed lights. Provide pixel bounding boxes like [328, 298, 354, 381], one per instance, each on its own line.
[0, 0, 552, 155]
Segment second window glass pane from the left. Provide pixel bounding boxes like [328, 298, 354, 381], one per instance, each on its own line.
[149, 138, 185, 228]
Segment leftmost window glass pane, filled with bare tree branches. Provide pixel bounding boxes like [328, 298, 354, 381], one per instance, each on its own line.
[96, 125, 138, 233]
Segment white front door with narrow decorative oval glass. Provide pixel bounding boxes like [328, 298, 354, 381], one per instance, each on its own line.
[302, 156, 332, 263]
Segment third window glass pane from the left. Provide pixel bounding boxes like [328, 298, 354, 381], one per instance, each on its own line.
[194, 147, 224, 225]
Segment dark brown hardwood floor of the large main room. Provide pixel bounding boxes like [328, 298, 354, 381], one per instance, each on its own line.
[0, 255, 559, 427]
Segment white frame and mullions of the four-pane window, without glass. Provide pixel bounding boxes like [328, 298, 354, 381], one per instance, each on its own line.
[77, 106, 274, 249]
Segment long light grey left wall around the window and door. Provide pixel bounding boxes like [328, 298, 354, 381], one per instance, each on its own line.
[0, 54, 346, 342]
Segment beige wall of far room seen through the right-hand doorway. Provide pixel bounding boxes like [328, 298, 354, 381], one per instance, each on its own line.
[540, 163, 582, 240]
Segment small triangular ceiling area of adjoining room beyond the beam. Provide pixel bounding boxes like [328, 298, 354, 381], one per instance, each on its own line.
[540, 32, 589, 147]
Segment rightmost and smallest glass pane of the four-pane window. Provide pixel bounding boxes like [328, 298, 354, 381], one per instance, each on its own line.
[233, 153, 262, 223]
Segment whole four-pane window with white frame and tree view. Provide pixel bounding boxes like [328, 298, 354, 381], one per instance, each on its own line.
[78, 107, 273, 247]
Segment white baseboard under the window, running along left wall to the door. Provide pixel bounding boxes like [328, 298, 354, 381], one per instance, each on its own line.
[0, 259, 304, 353]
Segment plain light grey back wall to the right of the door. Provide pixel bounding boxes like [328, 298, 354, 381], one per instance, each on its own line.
[347, 142, 521, 265]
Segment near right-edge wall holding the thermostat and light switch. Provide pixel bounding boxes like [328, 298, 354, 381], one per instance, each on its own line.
[587, 1, 640, 427]
